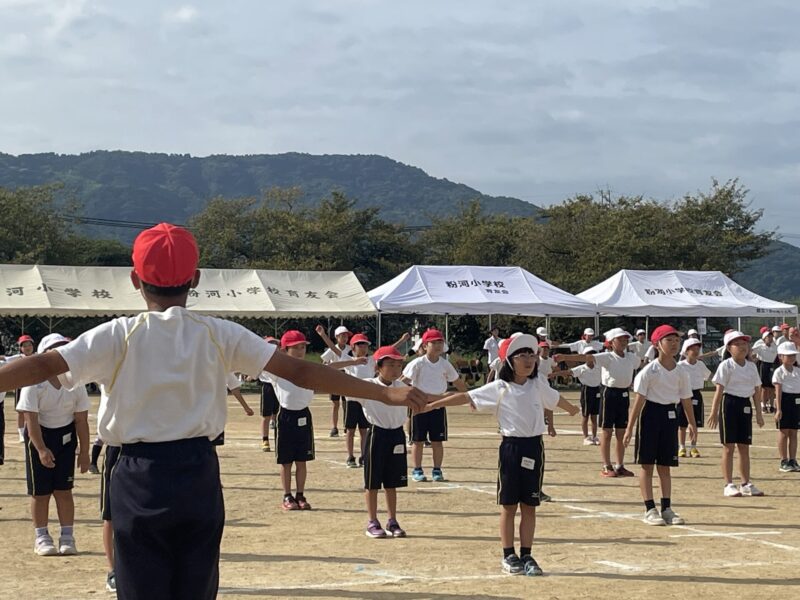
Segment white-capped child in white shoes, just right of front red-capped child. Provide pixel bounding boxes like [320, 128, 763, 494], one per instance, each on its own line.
[706, 330, 764, 497]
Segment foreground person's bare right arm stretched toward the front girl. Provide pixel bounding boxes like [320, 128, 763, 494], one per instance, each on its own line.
[264, 352, 428, 410]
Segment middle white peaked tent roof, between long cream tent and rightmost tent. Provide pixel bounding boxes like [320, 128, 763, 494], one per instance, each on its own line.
[369, 266, 596, 317]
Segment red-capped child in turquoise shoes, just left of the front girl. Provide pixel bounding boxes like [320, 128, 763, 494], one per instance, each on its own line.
[403, 329, 467, 481]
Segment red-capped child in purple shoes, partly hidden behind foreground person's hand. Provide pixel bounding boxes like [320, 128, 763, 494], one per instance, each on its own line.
[361, 346, 408, 538]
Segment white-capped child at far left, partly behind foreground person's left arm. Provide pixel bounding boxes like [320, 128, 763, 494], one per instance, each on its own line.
[17, 333, 89, 556]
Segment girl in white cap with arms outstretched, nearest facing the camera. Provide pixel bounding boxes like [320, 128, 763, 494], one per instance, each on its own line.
[428, 334, 578, 576]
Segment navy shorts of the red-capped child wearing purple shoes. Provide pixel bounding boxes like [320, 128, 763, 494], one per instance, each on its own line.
[364, 425, 408, 490]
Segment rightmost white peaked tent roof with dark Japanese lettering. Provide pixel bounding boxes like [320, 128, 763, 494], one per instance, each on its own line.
[578, 269, 797, 317]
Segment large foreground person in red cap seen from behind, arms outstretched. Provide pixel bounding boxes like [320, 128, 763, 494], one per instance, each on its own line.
[0, 223, 427, 600]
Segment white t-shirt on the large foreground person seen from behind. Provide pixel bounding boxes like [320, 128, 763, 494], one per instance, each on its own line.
[56, 306, 275, 446]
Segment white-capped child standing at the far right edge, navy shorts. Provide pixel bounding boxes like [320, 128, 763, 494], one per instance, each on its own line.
[772, 342, 800, 473]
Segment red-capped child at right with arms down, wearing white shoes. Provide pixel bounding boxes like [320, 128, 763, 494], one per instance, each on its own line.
[623, 325, 696, 525]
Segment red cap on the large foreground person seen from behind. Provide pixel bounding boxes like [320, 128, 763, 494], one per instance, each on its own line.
[133, 223, 199, 287]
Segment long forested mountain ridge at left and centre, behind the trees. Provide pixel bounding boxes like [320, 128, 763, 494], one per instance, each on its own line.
[0, 151, 538, 233]
